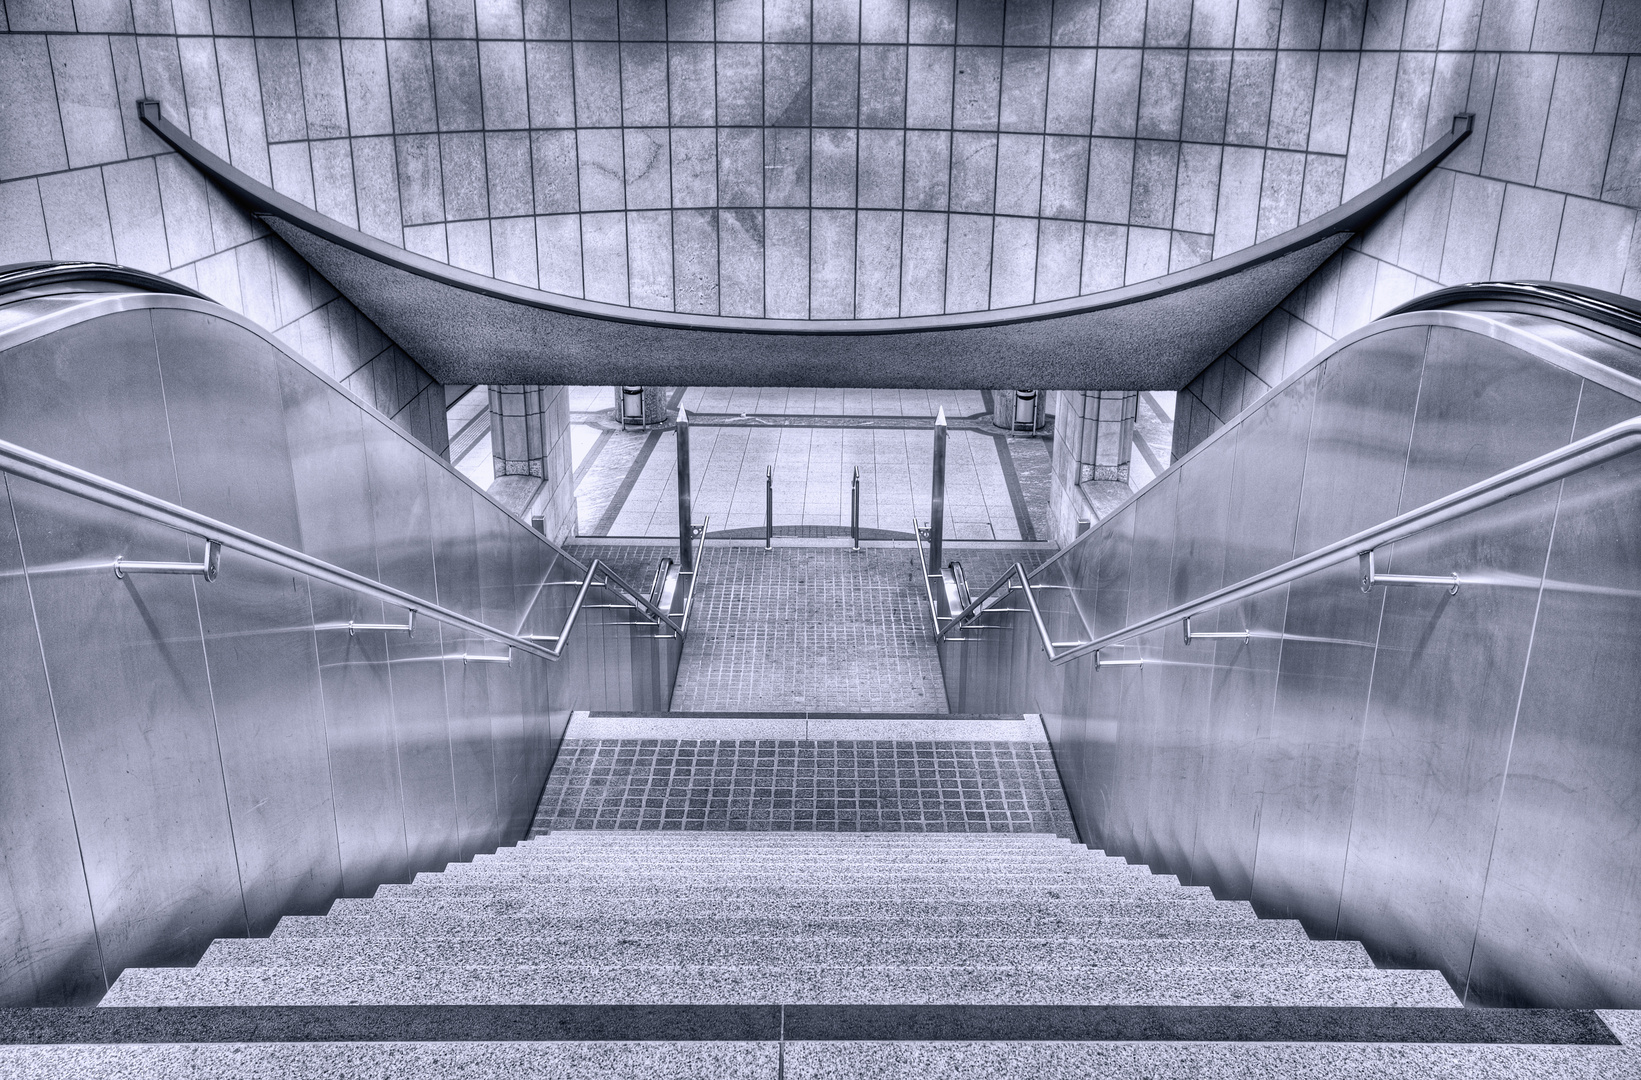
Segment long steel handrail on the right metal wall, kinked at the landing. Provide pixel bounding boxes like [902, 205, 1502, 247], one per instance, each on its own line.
[945, 417, 1641, 665]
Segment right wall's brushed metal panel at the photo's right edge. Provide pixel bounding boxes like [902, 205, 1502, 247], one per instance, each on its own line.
[1465, 375, 1641, 1008]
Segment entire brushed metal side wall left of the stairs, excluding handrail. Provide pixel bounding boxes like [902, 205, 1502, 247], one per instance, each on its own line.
[0, 283, 679, 1004]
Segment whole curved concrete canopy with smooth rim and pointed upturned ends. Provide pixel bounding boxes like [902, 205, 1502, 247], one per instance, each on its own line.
[139, 102, 1470, 389]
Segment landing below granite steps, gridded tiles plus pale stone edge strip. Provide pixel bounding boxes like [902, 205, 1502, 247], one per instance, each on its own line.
[530, 714, 1076, 837]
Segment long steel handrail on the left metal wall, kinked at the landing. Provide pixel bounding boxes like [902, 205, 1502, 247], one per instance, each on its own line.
[0, 440, 683, 660]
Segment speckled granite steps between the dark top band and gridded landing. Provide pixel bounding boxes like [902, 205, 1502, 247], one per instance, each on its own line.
[103, 831, 1457, 1006]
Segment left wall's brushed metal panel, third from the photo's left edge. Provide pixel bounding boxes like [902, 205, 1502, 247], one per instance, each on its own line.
[153, 310, 341, 934]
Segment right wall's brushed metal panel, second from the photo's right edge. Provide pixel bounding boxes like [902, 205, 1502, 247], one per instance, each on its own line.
[1339, 328, 1580, 985]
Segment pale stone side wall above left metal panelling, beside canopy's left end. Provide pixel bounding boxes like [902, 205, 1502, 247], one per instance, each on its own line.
[0, 18, 448, 453]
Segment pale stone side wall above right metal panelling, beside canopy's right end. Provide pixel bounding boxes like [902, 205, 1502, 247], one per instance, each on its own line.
[1173, 0, 1641, 458]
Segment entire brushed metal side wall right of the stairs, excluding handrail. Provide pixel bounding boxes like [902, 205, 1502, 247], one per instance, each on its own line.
[940, 300, 1641, 1008]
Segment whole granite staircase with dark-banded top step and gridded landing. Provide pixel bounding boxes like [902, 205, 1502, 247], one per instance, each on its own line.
[0, 717, 1641, 1080]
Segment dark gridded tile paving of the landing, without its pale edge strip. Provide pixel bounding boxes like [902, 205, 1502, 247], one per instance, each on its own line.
[530, 739, 1075, 837]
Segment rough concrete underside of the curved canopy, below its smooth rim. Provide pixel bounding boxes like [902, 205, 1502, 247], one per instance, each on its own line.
[269, 218, 1352, 389]
